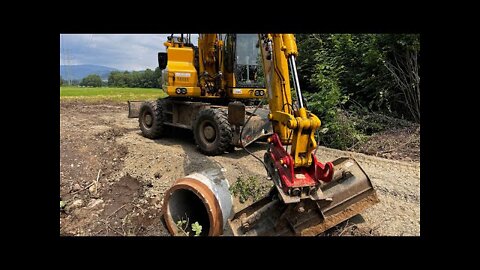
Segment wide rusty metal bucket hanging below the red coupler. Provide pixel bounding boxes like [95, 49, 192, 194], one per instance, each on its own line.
[229, 157, 379, 236]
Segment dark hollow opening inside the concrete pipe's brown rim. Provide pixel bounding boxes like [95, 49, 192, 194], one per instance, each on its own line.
[168, 189, 210, 236]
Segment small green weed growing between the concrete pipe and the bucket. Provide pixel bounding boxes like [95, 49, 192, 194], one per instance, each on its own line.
[230, 176, 271, 203]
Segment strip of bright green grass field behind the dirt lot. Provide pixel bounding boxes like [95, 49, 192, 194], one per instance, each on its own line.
[60, 86, 166, 102]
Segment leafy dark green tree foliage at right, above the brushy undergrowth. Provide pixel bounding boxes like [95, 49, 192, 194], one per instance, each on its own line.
[297, 34, 420, 121]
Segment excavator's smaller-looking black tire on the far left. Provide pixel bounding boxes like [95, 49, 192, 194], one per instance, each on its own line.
[138, 100, 165, 139]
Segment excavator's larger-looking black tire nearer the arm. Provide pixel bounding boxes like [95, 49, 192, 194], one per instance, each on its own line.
[193, 108, 232, 156]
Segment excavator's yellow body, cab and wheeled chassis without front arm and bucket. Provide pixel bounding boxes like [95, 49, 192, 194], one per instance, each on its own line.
[129, 34, 272, 155]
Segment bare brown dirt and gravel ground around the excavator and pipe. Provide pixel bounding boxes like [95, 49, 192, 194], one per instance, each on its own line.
[60, 101, 420, 236]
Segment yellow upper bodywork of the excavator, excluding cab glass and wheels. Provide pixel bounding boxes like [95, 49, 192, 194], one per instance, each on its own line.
[163, 34, 266, 100]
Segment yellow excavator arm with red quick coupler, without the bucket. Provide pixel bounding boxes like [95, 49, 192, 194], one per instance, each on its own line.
[259, 34, 333, 202]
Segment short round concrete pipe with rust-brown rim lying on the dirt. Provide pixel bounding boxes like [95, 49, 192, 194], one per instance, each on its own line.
[162, 169, 233, 236]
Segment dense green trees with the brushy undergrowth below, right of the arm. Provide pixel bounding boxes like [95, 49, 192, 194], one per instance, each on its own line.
[296, 34, 420, 149]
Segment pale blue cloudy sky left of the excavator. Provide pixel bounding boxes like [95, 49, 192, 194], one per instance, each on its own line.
[60, 34, 197, 71]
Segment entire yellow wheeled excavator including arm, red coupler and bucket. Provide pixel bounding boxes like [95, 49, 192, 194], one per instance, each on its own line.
[131, 34, 379, 236]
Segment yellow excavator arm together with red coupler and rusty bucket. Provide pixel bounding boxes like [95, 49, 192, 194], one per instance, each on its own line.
[229, 34, 379, 236]
